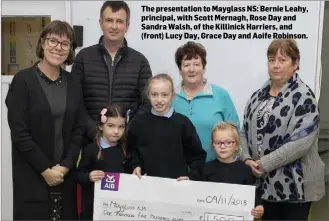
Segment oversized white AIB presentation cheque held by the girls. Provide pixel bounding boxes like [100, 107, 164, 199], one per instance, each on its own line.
[93, 173, 255, 221]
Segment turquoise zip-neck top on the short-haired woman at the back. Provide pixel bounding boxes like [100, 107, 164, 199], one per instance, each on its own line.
[172, 83, 240, 162]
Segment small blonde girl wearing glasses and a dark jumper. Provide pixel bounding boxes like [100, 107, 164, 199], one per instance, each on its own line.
[203, 122, 264, 219]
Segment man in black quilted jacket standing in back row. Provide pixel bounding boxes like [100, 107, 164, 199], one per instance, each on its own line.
[72, 1, 152, 143]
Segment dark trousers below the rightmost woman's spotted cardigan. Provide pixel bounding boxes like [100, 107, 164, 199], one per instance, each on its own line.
[262, 201, 311, 221]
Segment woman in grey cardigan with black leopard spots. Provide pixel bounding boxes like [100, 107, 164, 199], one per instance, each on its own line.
[241, 39, 325, 220]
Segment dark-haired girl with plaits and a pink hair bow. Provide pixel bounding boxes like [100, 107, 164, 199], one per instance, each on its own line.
[77, 104, 128, 220]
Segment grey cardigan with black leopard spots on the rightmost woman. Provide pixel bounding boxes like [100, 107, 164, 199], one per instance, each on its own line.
[241, 73, 325, 202]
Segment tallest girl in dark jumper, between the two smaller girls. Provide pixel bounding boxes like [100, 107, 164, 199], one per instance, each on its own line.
[127, 74, 206, 180]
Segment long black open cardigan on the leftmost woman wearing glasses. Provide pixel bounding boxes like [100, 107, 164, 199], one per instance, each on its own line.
[6, 67, 83, 216]
